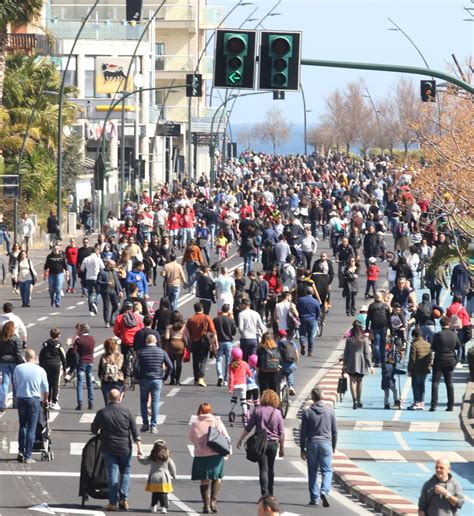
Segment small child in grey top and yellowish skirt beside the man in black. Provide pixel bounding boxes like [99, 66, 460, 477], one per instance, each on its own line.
[138, 439, 176, 514]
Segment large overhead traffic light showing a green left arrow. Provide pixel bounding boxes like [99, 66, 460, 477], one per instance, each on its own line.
[214, 29, 256, 90]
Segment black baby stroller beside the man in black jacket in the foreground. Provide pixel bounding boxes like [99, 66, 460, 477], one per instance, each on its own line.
[79, 435, 109, 507]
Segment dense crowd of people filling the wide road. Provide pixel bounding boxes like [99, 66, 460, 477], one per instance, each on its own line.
[0, 148, 474, 513]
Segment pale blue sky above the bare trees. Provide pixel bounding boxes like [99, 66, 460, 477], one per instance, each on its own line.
[208, 0, 474, 127]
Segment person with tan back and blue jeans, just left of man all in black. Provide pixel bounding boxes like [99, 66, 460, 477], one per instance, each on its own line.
[407, 328, 433, 410]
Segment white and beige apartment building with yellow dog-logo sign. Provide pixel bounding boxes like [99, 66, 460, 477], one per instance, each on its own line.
[43, 0, 222, 208]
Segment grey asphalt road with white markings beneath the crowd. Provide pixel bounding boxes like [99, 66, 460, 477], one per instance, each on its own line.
[0, 242, 378, 516]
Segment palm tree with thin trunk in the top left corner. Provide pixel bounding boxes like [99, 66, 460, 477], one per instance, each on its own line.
[0, 0, 44, 106]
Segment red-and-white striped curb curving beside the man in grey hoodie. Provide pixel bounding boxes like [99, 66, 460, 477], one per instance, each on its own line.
[314, 363, 418, 516]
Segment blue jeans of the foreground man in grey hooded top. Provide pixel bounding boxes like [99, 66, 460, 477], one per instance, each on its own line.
[306, 441, 332, 503]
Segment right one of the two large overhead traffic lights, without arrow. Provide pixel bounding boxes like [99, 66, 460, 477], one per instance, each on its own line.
[258, 31, 301, 91]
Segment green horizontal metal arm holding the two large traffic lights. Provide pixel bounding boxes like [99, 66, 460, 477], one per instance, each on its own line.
[301, 59, 474, 94]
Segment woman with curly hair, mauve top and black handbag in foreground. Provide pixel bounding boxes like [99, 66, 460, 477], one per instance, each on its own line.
[237, 389, 285, 496]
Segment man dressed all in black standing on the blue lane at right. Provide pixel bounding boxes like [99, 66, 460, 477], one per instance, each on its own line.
[430, 317, 461, 412]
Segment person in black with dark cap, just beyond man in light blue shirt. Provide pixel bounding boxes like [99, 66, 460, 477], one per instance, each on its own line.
[39, 328, 66, 410]
